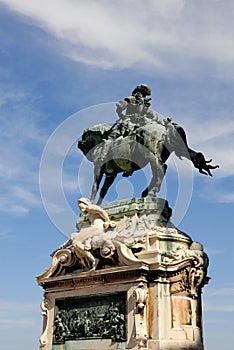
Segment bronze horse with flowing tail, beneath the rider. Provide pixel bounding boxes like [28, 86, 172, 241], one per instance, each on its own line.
[78, 120, 218, 205]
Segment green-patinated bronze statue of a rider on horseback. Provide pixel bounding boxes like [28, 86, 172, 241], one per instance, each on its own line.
[78, 84, 219, 205]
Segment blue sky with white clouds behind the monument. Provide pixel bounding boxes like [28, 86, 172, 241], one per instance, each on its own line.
[0, 0, 234, 350]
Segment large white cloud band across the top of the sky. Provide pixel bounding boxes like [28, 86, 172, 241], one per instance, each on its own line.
[0, 0, 234, 78]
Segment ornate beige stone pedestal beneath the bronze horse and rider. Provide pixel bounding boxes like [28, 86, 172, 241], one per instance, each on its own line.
[37, 198, 208, 350]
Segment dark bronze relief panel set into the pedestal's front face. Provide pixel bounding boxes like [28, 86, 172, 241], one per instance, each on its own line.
[53, 293, 126, 344]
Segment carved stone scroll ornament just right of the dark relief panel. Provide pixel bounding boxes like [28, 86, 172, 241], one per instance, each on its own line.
[133, 282, 148, 348]
